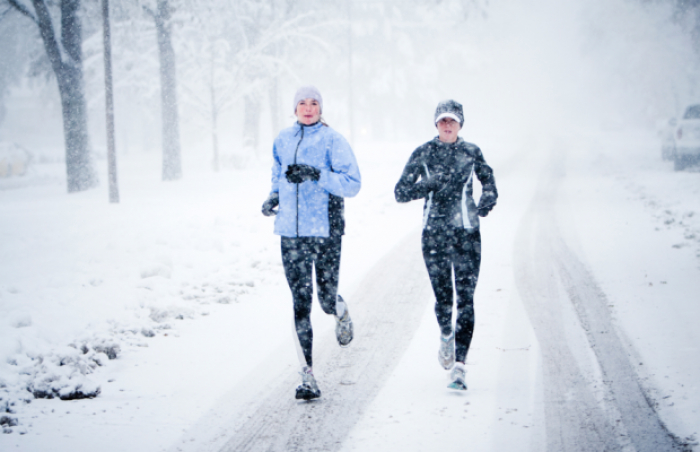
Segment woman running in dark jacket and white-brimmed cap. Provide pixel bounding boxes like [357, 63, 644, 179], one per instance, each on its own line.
[394, 100, 498, 390]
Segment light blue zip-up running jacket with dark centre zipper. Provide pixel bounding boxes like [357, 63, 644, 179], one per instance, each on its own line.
[271, 122, 361, 237]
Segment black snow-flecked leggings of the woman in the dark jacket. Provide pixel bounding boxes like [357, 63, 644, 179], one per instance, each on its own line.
[422, 227, 481, 362]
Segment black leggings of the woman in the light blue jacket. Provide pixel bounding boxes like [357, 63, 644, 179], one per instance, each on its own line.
[282, 235, 342, 366]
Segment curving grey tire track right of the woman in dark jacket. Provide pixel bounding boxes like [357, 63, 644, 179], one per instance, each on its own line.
[515, 149, 683, 452]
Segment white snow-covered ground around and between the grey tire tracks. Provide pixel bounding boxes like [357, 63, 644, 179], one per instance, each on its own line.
[0, 125, 700, 451]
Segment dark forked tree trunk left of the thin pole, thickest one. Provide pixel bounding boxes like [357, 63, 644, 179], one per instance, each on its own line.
[8, 0, 97, 193]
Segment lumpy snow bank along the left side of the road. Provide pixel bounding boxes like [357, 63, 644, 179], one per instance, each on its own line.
[0, 154, 288, 444]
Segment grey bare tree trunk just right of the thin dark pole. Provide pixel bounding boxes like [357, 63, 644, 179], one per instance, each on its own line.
[152, 0, 182, 180]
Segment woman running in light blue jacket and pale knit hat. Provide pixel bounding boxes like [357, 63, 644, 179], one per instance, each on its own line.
[262, 86, 361, 400]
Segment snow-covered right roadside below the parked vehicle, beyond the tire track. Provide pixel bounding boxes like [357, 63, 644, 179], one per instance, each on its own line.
[560, 131, 700, 445]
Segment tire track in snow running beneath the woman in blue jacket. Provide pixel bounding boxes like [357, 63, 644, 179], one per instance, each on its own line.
[220, 233, 432, 452]
